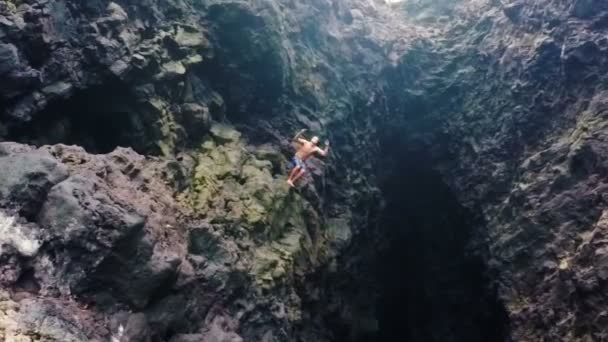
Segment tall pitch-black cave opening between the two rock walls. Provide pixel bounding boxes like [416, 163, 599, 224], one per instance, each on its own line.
[366, 138, 508, 342]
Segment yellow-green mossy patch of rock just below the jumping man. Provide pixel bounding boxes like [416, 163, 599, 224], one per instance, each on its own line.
[182, 124, 334, 288]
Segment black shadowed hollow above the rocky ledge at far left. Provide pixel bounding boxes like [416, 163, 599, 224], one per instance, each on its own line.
[7, 81, 147, 153]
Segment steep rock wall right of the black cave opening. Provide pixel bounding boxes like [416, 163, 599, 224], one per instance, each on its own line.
[380, 1, 608, 341]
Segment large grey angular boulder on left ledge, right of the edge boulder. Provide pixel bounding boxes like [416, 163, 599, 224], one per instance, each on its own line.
[38, 176, 145, 291]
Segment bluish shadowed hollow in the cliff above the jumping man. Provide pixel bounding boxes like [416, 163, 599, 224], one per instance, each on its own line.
[199, 3, 287, 122]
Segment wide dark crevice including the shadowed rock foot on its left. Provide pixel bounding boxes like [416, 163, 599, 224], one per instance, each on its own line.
[301, 141, 509, 342]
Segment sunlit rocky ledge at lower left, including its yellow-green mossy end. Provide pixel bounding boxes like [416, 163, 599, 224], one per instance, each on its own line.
[0, 125, 328, 341]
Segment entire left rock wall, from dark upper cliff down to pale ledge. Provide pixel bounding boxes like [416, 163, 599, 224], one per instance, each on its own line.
[0, 1, 394, 341]
